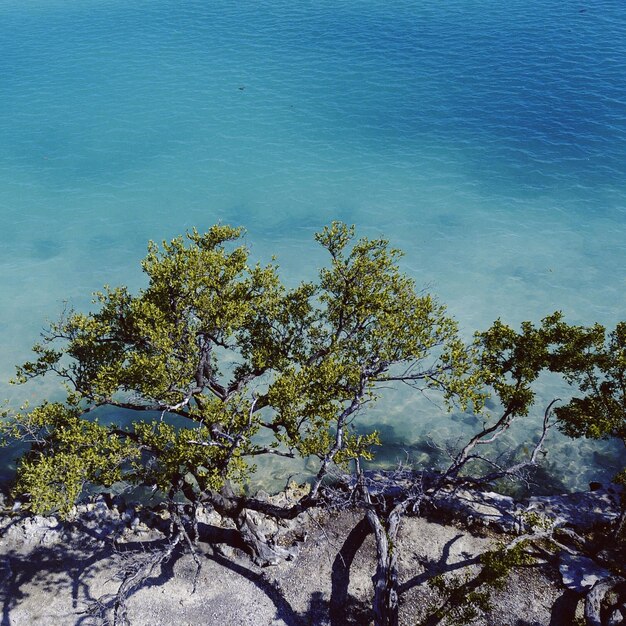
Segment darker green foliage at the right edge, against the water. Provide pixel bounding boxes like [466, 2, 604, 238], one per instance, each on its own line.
[477, 312, 626, 478]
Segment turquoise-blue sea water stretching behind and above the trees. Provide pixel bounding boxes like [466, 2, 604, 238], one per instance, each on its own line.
[0, 0, 626, 488]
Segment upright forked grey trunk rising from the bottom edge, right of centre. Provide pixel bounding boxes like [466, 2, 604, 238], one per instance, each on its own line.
[366, 504, 406, 626]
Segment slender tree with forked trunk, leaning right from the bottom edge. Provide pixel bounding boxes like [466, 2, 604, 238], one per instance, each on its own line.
[348, 318, 556, 626]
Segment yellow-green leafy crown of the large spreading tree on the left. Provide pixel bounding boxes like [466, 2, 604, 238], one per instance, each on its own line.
[5, 222, 478, 512]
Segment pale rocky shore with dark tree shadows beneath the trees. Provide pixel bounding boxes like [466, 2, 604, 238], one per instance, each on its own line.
[0, 477, 626, 626]
